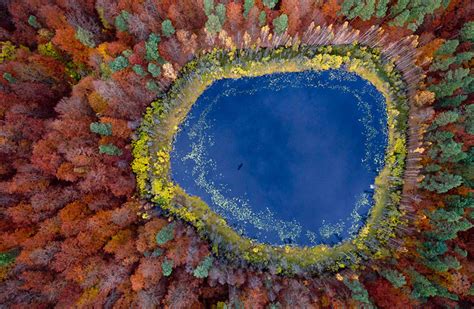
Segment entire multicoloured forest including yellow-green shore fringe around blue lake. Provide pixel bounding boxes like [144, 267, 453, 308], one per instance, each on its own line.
[0, 0, 474, 308]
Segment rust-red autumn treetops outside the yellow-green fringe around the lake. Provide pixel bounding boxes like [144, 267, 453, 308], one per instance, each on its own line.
[0, 0, 474, 308]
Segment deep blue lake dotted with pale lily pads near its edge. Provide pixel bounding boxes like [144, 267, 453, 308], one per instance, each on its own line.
[171, 70, 387, 245]
